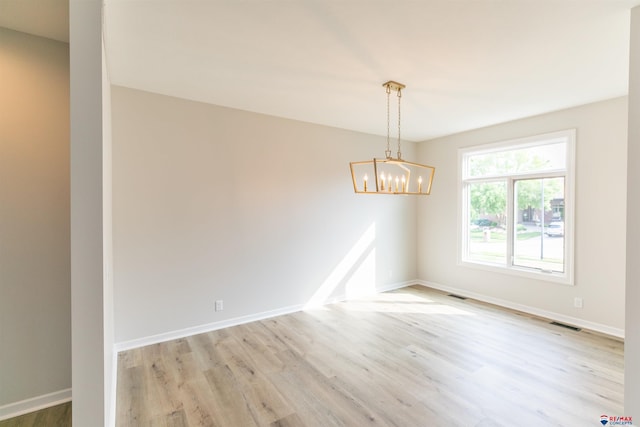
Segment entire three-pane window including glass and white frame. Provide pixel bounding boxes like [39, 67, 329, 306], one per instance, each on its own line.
[460, 130, 575, 284]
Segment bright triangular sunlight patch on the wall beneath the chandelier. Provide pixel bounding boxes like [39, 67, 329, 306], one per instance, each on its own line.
[305, 223, 376, 309]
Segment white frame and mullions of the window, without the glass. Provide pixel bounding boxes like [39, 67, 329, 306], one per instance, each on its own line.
[458, 129, 576, 285]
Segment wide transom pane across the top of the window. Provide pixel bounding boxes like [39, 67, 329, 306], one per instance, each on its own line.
[468, 142, 567, 178]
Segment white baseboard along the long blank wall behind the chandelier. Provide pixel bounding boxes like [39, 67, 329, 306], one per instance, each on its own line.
[114, 280, 418, 353]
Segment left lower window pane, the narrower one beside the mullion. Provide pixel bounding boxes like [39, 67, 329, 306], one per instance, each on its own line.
[467, 181, 507, 265]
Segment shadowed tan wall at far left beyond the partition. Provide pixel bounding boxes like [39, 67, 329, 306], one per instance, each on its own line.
[0, 28, 71, 418]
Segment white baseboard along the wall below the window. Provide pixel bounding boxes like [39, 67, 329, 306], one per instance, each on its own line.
[416, 280, 624, 339]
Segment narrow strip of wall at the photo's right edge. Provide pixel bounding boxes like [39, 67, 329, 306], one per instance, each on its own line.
[624, 7, 640, 417]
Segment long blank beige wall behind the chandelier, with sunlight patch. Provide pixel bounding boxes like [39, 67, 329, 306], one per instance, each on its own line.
[112, 87, 416, 344]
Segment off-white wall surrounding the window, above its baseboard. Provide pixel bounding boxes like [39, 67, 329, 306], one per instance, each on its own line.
[418, 97, 627, 334]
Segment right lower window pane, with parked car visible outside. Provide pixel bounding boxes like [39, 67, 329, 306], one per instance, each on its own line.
[513, 177, 564, 273]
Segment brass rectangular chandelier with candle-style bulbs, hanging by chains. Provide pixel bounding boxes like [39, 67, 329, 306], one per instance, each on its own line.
[350, 81, 435, 196]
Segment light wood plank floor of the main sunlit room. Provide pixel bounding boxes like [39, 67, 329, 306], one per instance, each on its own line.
[117, 286, 624, 427]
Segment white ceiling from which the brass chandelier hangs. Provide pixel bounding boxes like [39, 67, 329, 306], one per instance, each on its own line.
[0, 0, 640, 141]
